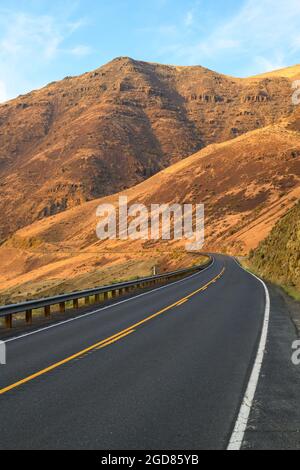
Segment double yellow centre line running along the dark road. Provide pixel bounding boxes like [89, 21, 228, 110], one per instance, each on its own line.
[0, 267, 225, 395]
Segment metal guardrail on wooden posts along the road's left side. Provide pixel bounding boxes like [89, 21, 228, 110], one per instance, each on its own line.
[0, 256, 212, 328]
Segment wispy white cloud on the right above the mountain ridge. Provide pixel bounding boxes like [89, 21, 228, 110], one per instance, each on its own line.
[158, 0, 300, 74]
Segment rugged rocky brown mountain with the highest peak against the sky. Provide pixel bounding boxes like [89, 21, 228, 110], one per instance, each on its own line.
[0, 58, 294, 242]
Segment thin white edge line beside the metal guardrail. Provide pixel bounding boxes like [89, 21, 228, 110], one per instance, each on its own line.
[2, 257, 215, 344]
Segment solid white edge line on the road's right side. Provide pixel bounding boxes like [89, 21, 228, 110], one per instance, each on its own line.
[227, 258, 271, 451]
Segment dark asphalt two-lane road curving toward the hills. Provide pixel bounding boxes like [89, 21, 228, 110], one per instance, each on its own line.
[0, 256, 265, 450]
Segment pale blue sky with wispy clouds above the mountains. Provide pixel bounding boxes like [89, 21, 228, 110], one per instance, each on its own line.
[0, 0, 300, 101]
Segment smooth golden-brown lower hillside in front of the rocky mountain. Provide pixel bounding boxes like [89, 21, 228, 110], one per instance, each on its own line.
[0, 108, 300, 299]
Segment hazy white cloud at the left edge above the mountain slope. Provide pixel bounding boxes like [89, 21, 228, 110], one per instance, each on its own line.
[0, 9, 88, 99]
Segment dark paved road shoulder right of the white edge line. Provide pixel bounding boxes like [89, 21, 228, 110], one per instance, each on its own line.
[243, 284, 300, 450]
